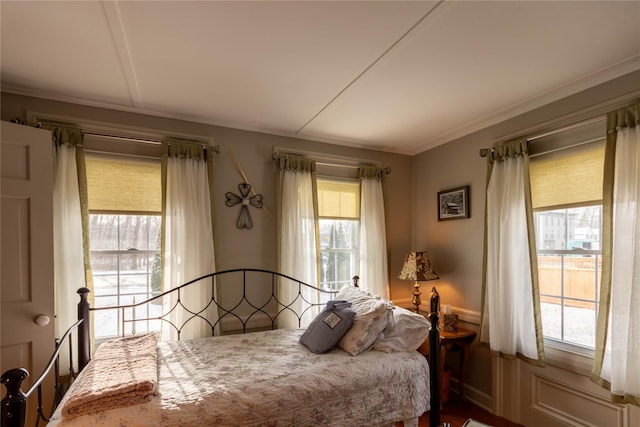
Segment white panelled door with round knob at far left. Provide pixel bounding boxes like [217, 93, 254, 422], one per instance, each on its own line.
[0, 122, 55, 425]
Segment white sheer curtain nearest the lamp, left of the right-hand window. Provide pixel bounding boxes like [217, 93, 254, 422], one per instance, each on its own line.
[481, 140, 544, 363]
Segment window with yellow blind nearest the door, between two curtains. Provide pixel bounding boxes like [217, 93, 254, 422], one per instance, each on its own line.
[86, 153, 162, 340]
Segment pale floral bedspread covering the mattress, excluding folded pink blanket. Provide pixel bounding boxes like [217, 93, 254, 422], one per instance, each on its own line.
[50, 330, 430, 427]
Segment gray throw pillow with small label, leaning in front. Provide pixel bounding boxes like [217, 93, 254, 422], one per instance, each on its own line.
[300, 300, 356, 353]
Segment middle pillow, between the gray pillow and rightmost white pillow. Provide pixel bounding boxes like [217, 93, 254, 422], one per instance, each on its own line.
[335, 286, 394, 356]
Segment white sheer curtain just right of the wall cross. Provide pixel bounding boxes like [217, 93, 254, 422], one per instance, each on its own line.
[277, 157, 319, 328]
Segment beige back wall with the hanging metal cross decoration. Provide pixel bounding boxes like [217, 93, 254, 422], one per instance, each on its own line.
[1, 93, 411, 298]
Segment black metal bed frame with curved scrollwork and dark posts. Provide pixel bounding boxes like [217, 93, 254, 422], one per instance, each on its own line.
[0, 268, 440, 427]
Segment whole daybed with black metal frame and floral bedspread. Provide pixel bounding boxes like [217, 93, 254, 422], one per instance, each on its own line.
[2, 269, 440, 427]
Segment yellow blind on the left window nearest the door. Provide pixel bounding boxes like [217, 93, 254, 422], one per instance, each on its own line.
[85, 152, 162, 214]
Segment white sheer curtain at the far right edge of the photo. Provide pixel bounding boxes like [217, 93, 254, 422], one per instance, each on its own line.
[594, 104, 640, 405]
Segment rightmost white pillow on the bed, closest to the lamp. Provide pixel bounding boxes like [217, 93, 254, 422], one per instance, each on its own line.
[373, 307, 431, 353]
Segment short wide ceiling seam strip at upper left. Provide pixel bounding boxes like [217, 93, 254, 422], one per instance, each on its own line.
[102, 0, 144, 108]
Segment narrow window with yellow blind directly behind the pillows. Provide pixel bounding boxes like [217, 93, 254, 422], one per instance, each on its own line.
[317, 178, 360, 290]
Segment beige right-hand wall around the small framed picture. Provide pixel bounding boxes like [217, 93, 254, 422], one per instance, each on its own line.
[412, 72, 640, 402]
